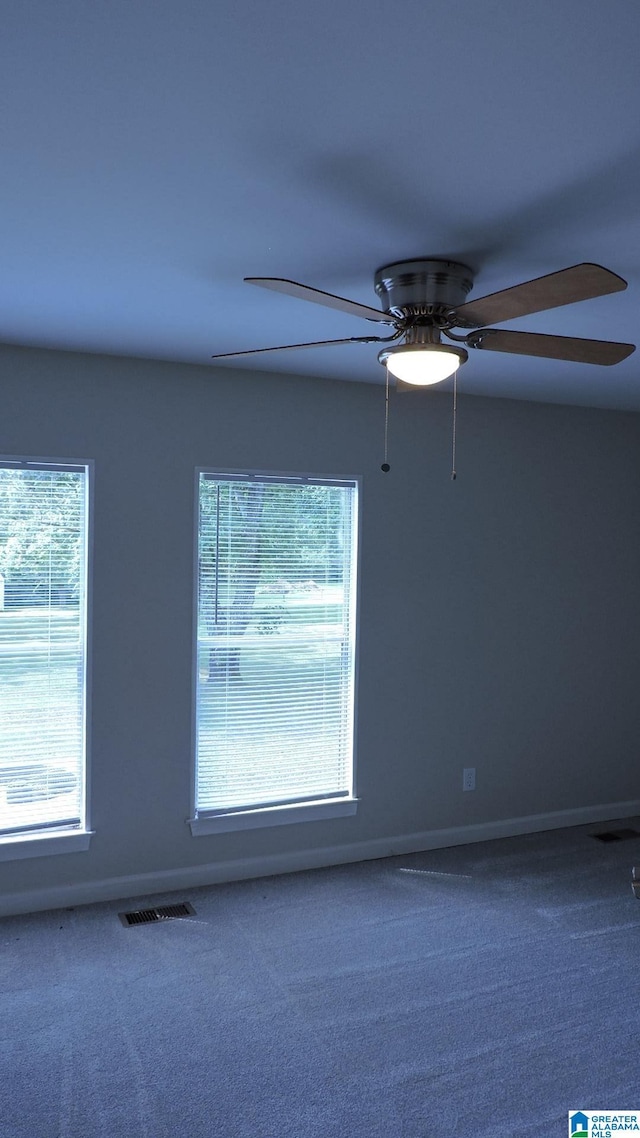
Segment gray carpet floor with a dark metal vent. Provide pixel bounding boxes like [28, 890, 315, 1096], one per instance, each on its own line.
[0, 819, 640, 1138]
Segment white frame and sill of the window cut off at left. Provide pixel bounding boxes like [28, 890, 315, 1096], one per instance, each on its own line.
[0, 454, 95, 861]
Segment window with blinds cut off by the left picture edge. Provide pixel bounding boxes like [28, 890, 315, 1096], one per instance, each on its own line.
[0, 459, 88, 852]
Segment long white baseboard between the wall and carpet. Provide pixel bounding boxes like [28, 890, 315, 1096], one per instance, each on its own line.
[0, 799, 640, 916]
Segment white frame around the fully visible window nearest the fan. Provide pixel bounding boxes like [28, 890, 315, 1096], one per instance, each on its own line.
[187, 467, 362, 838]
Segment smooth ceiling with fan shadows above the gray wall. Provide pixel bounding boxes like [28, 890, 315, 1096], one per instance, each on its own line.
[0, 0, 640, 410]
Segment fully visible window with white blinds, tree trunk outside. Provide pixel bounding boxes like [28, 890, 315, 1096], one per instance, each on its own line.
[191, 471, 358, 833]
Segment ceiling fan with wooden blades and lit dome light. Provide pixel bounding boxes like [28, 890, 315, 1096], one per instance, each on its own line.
[212, 257, 635, 389]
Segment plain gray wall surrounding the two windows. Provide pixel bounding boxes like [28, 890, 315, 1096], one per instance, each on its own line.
[0, 347, 640, 908]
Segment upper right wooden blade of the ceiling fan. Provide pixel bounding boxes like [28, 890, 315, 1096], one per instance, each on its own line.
[456, 263, 626, 328]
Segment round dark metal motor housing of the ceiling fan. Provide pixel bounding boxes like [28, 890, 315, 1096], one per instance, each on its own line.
[374, 257, 474, 320]
